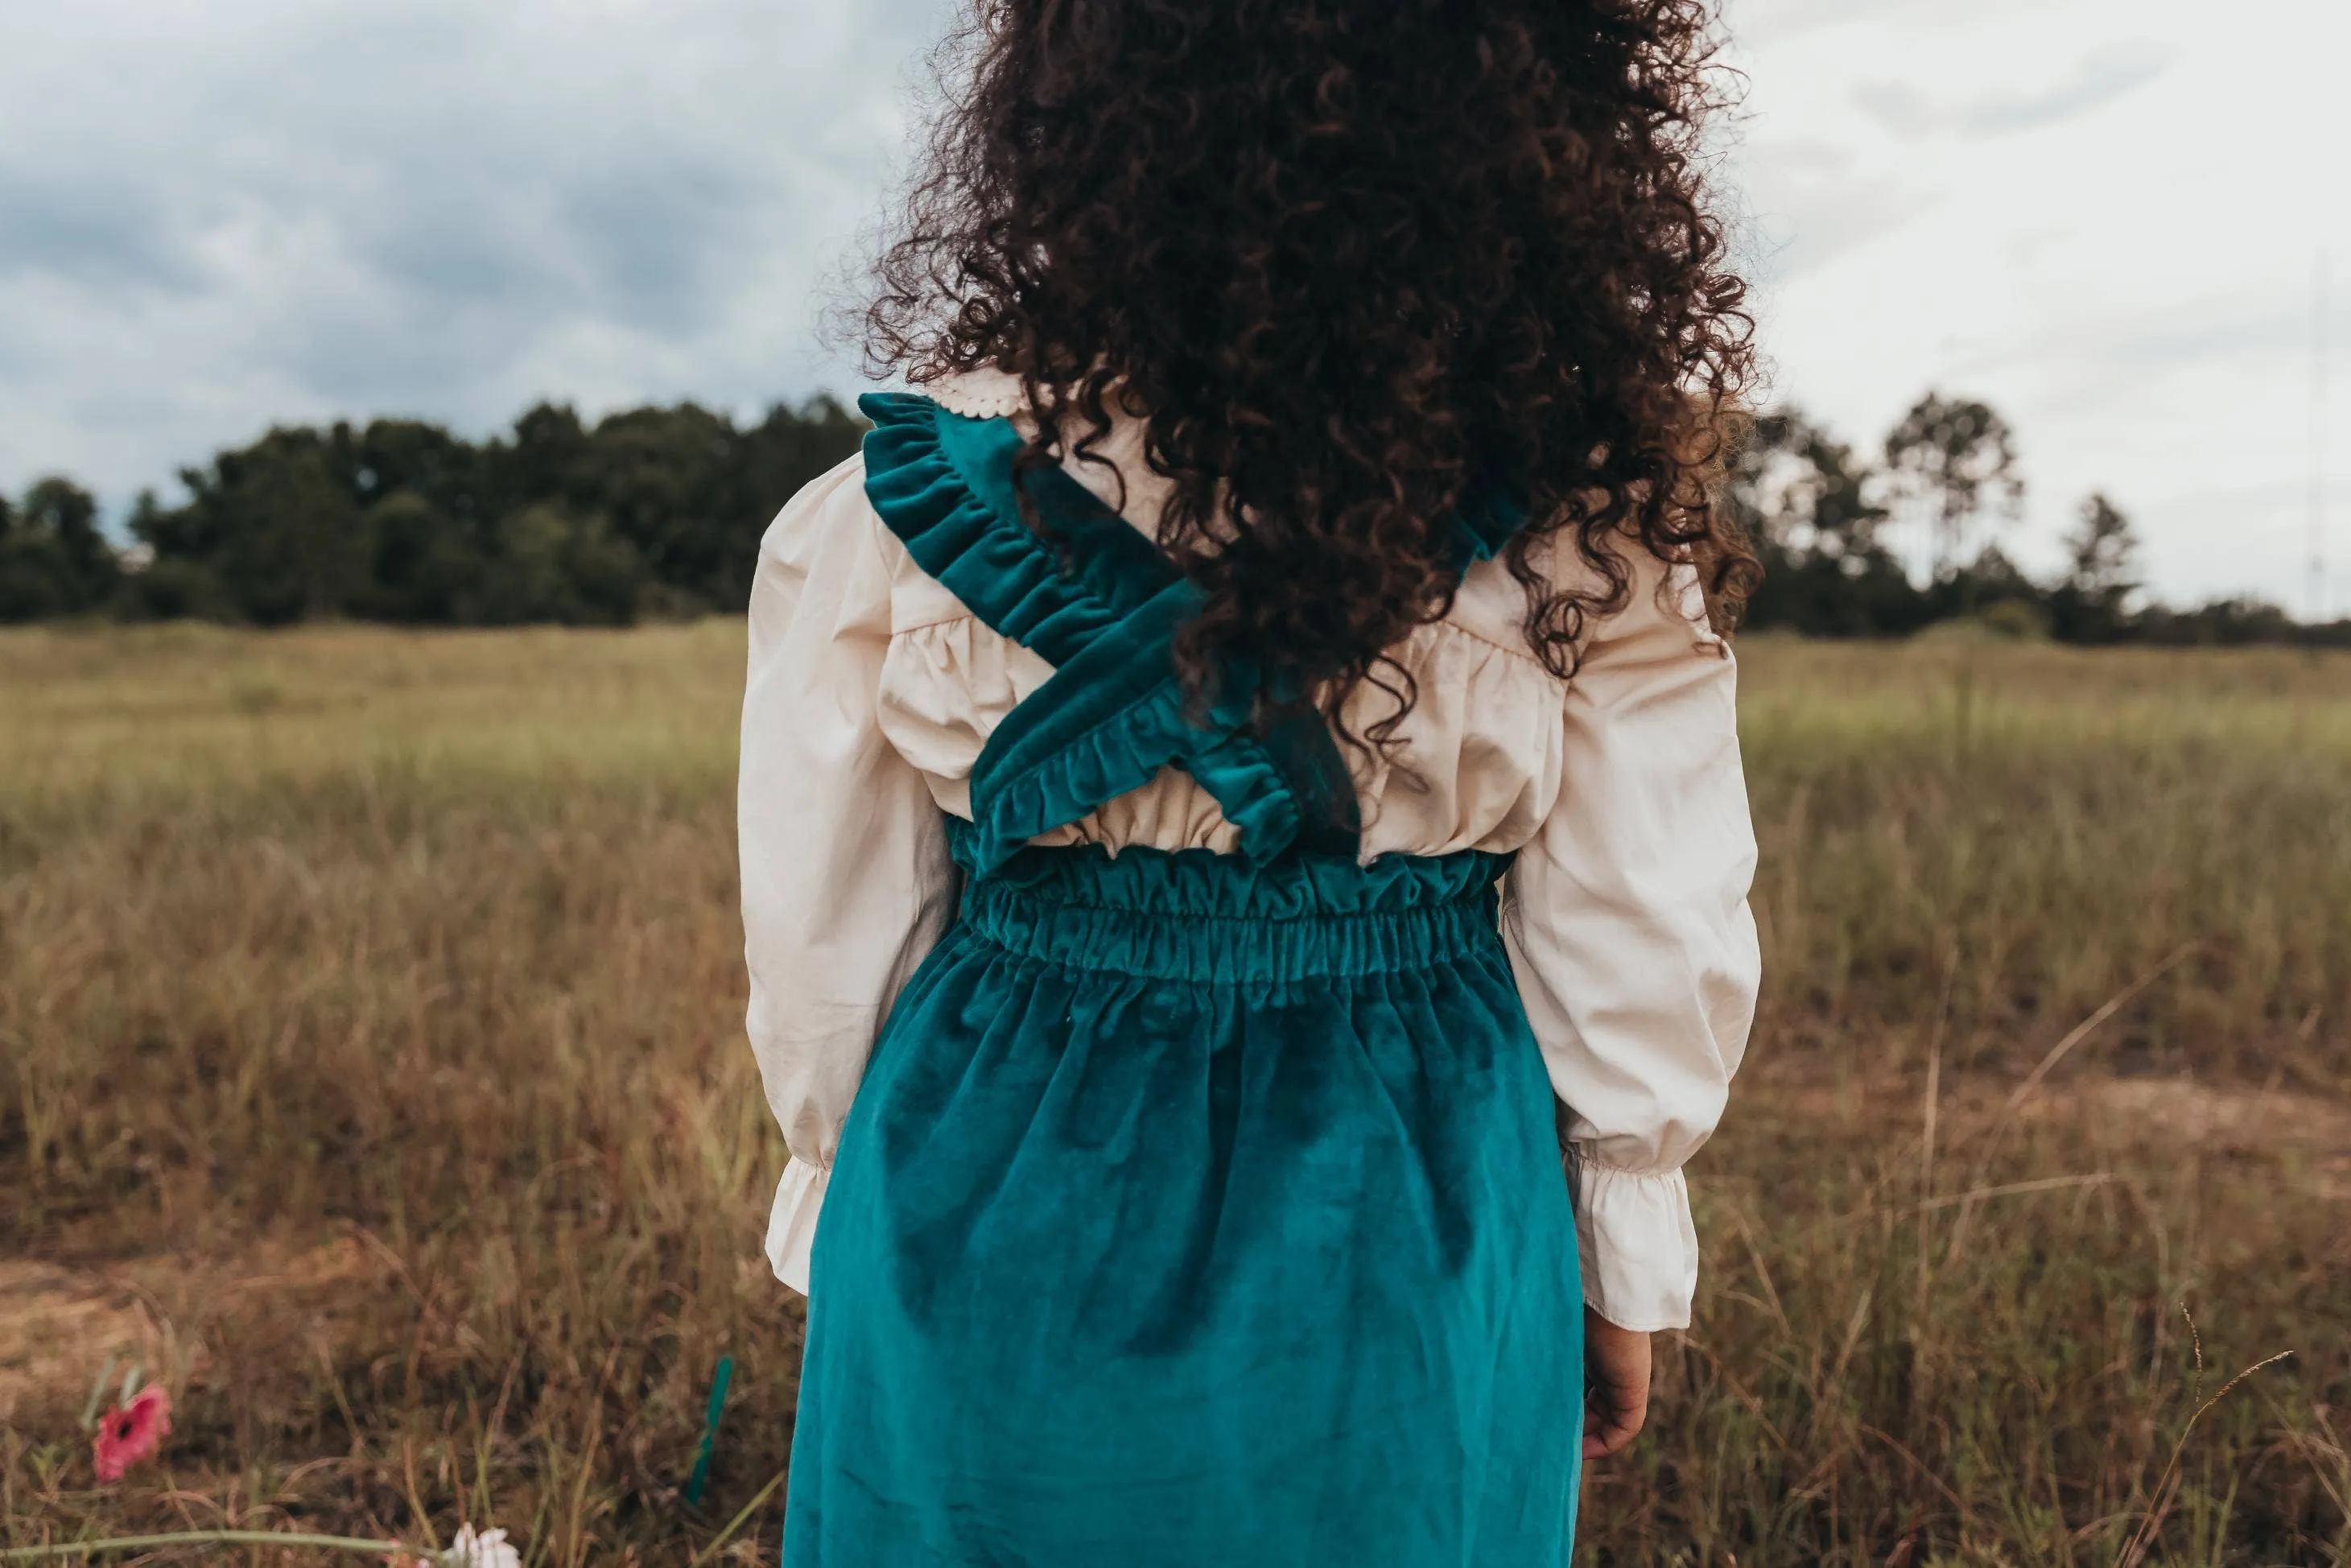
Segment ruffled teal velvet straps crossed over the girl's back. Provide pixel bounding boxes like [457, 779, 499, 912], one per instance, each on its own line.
[858, 393, 1514, 873]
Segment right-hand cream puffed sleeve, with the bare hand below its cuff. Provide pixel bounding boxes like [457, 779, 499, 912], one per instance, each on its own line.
[1504, 564, 1761, 1331]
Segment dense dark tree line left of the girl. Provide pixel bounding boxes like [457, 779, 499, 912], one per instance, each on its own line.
[0, 398, 865, 625]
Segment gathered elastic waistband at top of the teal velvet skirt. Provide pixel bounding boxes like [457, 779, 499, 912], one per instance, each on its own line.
[962, 846, 1507, 985]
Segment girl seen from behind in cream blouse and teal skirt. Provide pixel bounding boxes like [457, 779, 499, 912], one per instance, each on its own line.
[740, 0, 1756, 1568]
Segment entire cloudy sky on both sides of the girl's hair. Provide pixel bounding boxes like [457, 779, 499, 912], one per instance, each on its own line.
[0, 0, 2351, 613]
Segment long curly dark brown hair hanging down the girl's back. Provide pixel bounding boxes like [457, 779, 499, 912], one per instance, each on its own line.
[865, 0, 1756, 741]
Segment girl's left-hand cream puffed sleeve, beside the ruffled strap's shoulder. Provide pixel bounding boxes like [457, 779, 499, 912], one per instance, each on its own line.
[736, 459, 955, 1290]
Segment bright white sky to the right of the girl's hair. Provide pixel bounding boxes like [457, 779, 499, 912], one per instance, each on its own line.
[1730, 0, 2351, 611]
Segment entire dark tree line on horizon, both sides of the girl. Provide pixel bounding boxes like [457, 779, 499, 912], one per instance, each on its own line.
[0, 395, 2351, 646]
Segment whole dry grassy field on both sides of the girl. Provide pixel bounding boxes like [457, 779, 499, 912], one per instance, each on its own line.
[0, 625, 2351, 1568]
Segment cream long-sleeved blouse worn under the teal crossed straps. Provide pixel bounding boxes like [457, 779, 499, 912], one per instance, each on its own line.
[738, 376, 1761, 1328]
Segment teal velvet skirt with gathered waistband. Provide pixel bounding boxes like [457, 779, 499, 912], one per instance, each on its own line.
[783, 848, 1582, 1568]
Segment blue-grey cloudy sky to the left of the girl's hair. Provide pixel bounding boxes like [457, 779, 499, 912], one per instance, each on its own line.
[0, 0, 945, 503]
